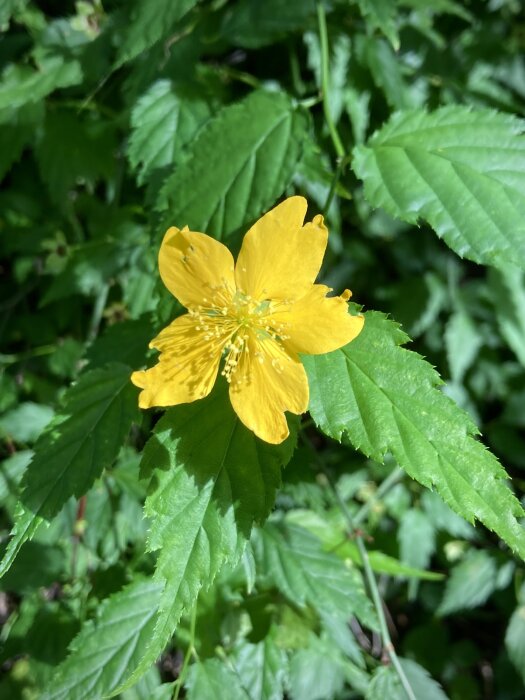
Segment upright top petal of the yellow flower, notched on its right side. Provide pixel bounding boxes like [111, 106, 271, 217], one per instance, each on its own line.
[235, 197, 328, 299]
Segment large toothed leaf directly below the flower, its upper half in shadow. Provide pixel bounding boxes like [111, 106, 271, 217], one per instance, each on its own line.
[117, 381, 295, 687]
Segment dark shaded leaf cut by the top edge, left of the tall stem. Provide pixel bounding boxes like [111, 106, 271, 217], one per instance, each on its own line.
[221, 0, 315, 49]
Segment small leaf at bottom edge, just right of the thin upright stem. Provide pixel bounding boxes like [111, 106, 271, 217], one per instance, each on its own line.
[186, 659, 246, 700]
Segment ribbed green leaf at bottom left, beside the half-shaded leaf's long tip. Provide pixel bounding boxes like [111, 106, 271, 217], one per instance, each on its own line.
[41, 580, 162, 700]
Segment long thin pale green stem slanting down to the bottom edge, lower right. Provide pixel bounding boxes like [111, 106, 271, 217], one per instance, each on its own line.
[324, 471, 416, 700]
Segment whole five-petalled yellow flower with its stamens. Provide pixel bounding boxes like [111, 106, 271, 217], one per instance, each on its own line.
[131, 197, 364, 444]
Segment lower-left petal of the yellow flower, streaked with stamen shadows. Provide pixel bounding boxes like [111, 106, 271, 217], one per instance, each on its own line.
[131, 314, 222, 408]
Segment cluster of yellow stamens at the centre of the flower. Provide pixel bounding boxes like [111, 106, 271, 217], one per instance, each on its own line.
[188, 288, 289, 383]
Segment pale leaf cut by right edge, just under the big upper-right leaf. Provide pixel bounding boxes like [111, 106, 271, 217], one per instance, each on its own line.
[489, 265, 525, 367]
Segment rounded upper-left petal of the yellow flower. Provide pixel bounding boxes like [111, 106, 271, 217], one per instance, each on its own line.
[159, 226, 235, 307]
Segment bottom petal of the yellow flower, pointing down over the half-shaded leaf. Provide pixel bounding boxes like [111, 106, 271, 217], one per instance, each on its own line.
[230, 333, 308, 444]
